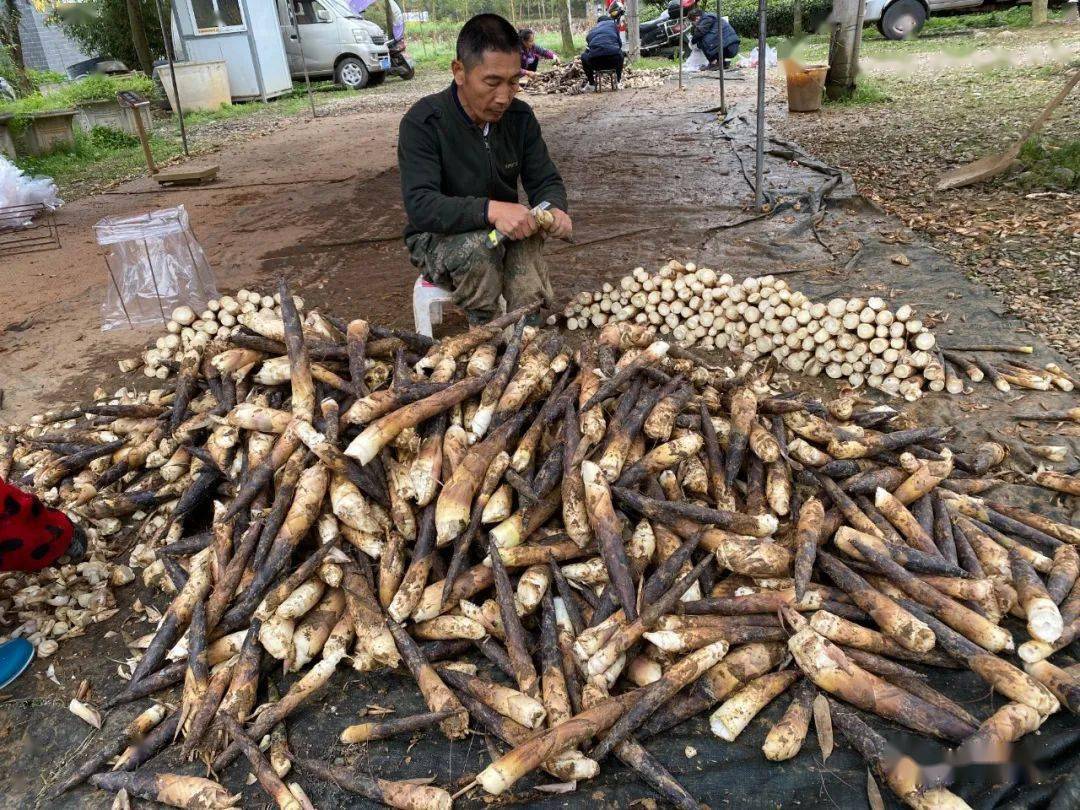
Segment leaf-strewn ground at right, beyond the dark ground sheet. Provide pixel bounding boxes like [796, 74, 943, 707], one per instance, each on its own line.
[772, 24, 1080, 363]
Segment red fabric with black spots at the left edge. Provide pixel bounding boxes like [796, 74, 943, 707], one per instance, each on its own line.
[0, 481, 75, 571]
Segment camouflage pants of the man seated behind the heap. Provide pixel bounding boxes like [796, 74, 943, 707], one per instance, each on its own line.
[405, 231, 554, 323]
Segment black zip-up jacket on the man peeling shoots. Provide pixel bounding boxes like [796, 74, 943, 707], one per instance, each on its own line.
[397, 84, 567, 237]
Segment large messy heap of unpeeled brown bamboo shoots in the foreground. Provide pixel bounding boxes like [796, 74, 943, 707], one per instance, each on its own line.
[0, 282, 1080, 808]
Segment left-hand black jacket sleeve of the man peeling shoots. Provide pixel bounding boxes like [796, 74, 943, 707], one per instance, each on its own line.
[397, 116, 490, 233]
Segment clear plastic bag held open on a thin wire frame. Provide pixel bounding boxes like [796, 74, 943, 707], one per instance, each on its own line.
[94, 205, 217, 332]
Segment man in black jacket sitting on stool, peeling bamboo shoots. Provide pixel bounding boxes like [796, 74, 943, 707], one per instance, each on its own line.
[397, 14, 573, 324]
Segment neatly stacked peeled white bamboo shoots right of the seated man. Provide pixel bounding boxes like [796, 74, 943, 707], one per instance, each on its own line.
[563, 259, 1075, 402]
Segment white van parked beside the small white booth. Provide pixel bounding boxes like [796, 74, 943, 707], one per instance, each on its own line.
[276, 0, 390, 90]
